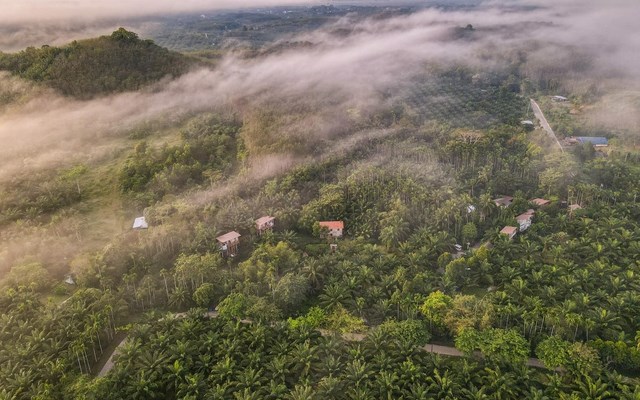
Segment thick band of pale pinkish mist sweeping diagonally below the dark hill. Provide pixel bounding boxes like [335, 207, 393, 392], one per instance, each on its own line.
[0, 0, 640, 181]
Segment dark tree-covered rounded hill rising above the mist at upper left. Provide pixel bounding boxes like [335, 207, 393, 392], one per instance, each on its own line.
[0, 28, 191, 99]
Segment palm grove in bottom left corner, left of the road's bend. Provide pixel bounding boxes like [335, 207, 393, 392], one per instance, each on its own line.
[0, 288, 126, 399]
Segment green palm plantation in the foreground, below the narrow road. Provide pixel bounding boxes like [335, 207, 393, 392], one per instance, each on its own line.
[76, 313, 638, 399]
